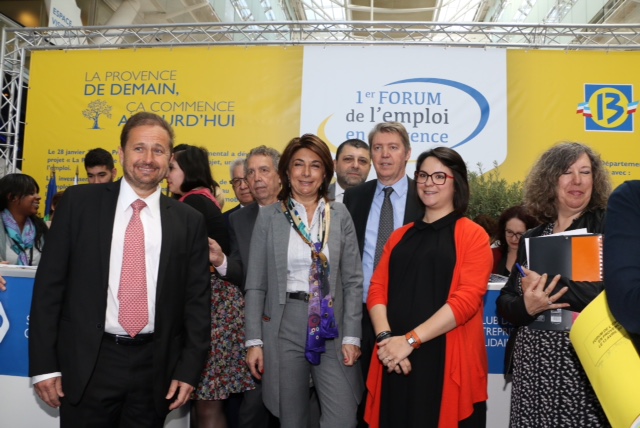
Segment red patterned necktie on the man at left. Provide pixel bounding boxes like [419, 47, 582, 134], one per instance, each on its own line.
[118, 199, 149, 337]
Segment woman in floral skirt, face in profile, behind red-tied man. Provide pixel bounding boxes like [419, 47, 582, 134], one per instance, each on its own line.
[167, 144, 254, 428]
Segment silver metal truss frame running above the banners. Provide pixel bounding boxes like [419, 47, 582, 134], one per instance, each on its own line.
[0, 21, 640, 175]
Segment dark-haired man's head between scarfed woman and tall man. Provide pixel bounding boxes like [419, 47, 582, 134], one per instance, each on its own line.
[329, 139, 371, 202]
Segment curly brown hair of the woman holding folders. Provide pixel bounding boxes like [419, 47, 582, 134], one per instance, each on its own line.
[524, 142, 611, 223]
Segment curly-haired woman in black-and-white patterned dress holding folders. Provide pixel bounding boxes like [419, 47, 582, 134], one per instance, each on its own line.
[497, 142, 611, 427]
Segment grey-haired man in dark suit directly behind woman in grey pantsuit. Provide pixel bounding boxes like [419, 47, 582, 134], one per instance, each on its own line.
[209, 146, 280, 428]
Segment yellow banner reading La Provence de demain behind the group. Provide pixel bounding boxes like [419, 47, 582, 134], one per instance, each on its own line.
[23, 47, 302, 209]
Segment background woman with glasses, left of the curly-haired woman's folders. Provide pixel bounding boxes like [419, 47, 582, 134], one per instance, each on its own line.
[492, 205, 538, 276]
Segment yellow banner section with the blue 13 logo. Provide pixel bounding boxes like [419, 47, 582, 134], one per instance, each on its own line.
[500, 50, 640, 186]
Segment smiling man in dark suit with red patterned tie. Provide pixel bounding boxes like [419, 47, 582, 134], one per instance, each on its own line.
[29, 112, 211, 428]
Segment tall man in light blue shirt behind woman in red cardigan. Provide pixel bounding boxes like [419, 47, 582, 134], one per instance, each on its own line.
[343, 122, 424, 426]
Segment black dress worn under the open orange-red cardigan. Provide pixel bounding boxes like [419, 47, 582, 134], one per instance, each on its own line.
[380, 213, 460, 428]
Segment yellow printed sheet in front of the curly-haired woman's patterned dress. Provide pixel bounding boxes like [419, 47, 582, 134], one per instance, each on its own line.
[569, 291, 640, 428]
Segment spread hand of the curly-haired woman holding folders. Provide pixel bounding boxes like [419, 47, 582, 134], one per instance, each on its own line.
[522, 268, 569, 316]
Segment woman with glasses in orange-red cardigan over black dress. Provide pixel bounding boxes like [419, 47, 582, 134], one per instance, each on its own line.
[365, 147, 493, 428]
